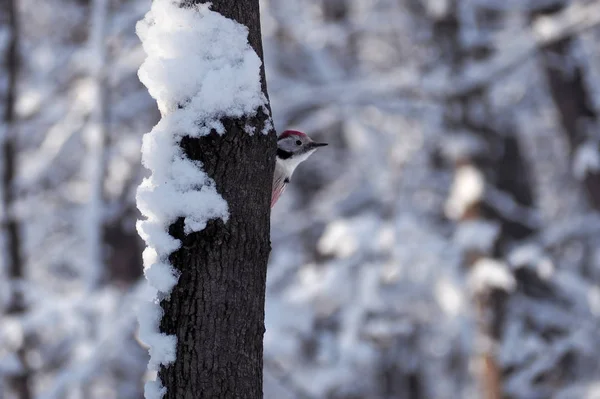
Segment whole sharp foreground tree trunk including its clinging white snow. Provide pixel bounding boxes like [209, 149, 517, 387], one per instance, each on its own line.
[137, 0, 276, 399]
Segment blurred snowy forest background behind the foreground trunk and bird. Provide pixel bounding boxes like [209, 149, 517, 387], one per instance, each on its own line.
[0, 0, 600, 399]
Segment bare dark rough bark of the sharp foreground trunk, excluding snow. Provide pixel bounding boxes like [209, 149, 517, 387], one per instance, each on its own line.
[159, 0, 276, 399]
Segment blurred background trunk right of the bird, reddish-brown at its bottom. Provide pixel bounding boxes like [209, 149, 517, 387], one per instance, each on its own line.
[426, 1, 534, 399]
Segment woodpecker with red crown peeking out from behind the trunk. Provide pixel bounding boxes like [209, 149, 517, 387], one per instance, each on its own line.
[271, 130, 327, 208]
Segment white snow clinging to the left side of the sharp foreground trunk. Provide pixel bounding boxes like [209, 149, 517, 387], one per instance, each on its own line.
[136, 0, 270, 399]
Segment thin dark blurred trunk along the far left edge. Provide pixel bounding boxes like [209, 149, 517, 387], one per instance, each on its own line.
[0, 0, 31, 399]
